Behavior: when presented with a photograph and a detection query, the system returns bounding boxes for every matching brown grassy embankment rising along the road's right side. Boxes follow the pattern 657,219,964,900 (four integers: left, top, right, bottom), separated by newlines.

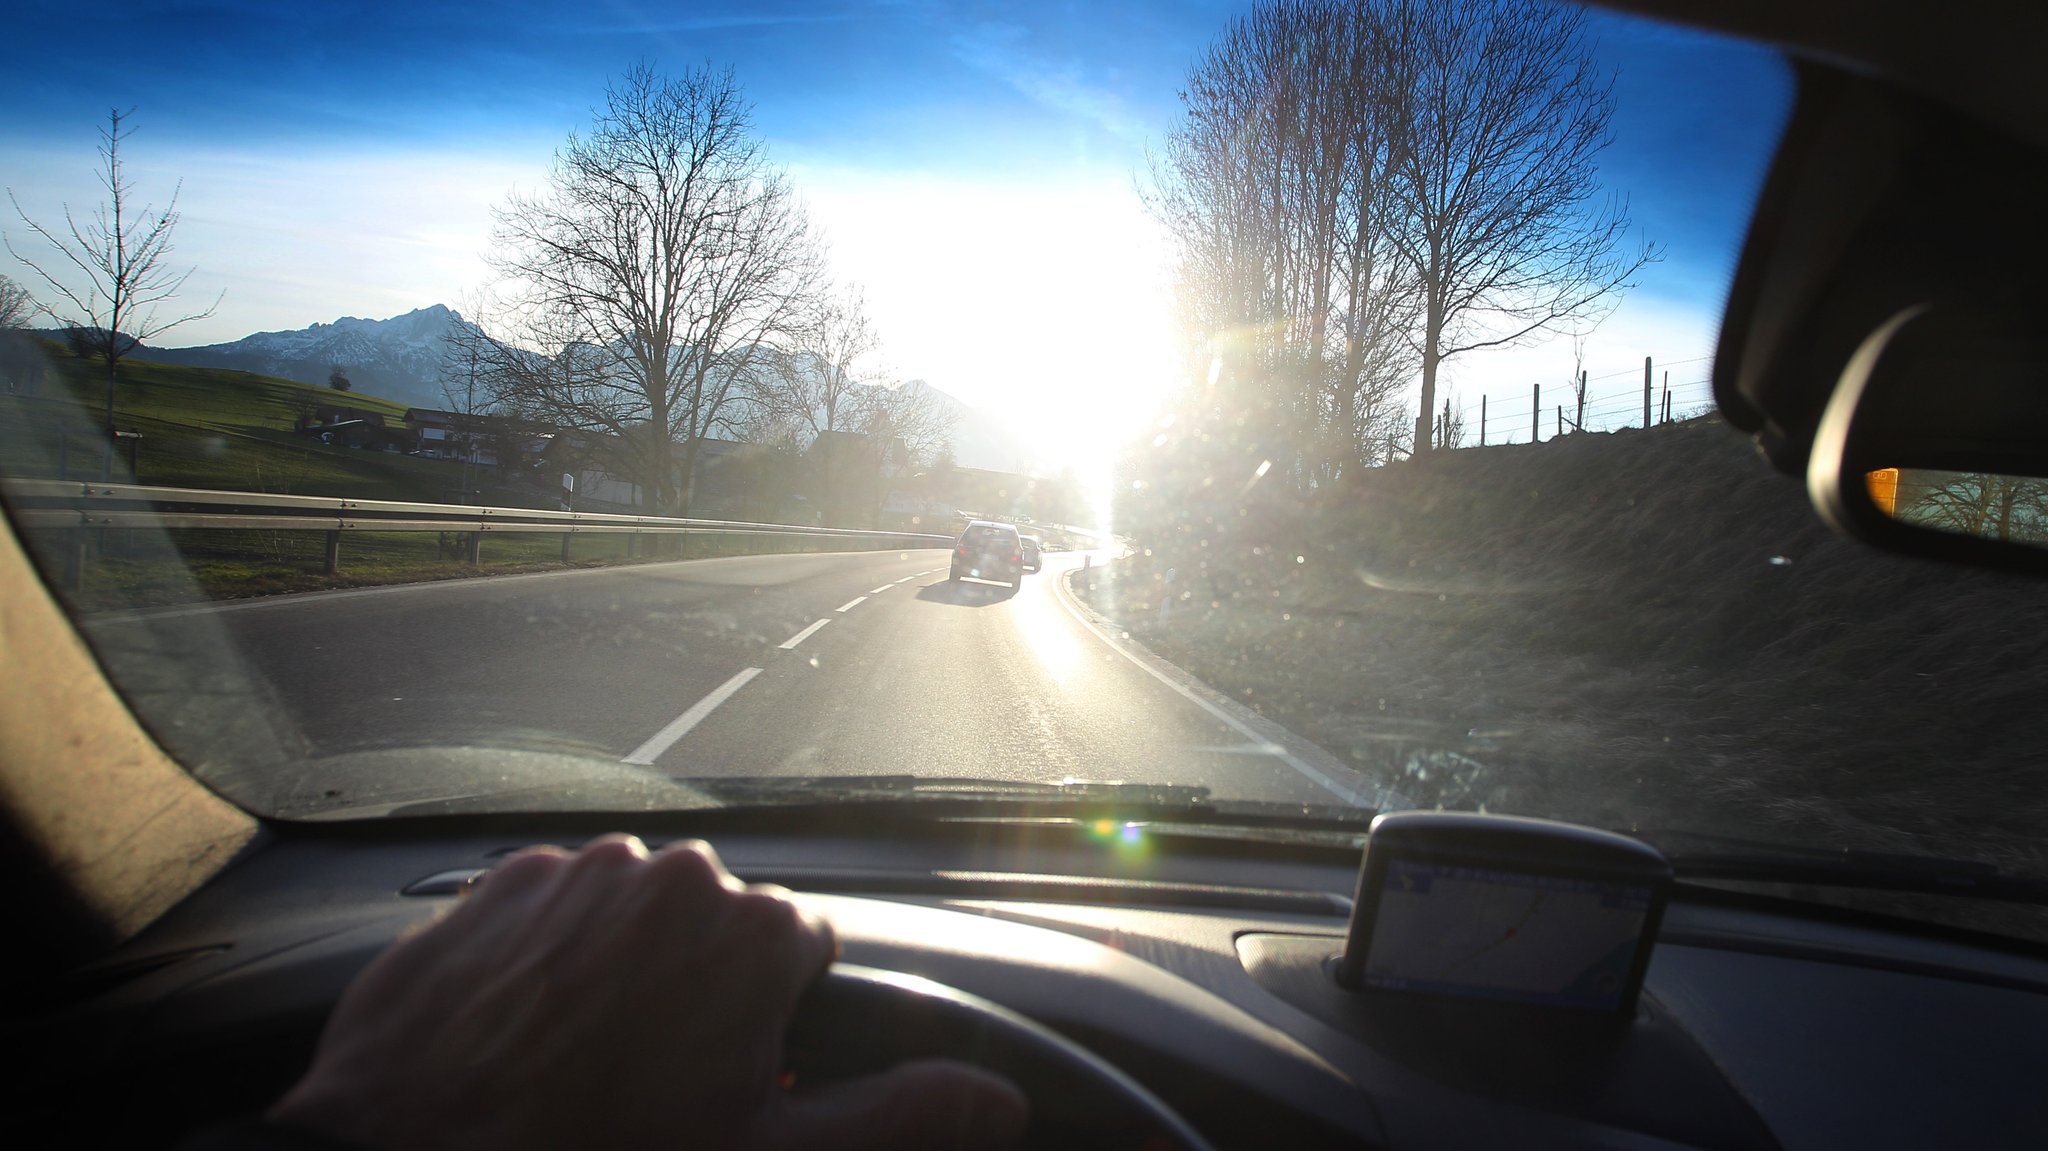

1094,422,2048,930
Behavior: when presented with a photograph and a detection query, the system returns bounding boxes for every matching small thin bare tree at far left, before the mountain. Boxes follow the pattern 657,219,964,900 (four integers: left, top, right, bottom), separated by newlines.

6,109,225,434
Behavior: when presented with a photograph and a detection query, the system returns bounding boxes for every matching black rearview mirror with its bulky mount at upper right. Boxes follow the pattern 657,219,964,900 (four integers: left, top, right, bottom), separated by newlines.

1714,59,2048,571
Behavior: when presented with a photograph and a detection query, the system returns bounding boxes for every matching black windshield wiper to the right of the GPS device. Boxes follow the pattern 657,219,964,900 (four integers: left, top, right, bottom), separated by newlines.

1624,832,2048,903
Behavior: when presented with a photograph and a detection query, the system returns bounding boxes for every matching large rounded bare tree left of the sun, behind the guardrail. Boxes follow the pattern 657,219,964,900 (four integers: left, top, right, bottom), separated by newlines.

475,66,821,512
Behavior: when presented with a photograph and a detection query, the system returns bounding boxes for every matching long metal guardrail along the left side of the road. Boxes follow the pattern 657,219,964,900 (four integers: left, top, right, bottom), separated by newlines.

0,479,952,590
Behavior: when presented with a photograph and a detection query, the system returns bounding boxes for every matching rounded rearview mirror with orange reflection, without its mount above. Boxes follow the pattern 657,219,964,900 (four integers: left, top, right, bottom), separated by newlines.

1806,303,2048,571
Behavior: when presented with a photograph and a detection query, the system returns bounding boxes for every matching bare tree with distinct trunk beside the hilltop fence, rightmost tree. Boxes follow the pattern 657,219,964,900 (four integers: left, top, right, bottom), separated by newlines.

1378,0,1657,453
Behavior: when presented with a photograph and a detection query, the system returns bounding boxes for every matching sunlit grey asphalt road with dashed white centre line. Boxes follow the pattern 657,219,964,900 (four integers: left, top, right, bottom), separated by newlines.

88,549,1376,807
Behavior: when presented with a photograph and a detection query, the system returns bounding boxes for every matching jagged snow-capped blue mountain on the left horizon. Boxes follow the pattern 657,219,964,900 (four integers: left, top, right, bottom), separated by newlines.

137,303,469,408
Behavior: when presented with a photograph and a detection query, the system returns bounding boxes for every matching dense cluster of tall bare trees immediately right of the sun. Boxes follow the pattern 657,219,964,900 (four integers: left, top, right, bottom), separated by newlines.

1153,0,1415,485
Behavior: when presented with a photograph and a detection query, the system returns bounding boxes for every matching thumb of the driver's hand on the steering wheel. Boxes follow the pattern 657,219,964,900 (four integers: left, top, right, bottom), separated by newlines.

760,1059,1030,1151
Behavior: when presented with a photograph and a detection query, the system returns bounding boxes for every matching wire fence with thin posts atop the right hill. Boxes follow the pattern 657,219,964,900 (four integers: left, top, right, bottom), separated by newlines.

1436,356,1714,449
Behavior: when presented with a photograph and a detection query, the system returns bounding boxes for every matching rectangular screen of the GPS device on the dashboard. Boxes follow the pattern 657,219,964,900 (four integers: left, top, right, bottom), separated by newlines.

1364,858,1651,1012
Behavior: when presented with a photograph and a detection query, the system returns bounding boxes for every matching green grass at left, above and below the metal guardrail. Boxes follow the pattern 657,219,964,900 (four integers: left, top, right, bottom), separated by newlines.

0,342,856,610
